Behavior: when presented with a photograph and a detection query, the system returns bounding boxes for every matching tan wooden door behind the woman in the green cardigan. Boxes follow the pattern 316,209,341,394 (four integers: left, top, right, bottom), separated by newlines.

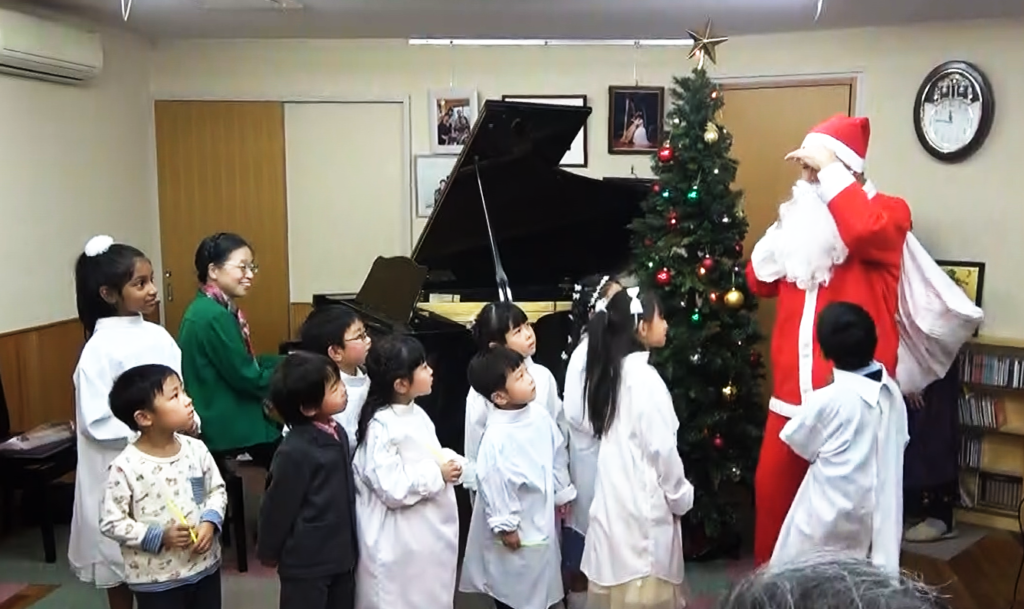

155,101,289,353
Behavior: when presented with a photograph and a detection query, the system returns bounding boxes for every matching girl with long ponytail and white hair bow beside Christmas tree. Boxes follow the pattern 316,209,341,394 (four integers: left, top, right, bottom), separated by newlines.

582,288,693,609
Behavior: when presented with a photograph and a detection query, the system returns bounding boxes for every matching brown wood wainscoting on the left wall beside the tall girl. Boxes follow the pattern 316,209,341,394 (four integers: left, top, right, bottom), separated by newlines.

0,308,160,431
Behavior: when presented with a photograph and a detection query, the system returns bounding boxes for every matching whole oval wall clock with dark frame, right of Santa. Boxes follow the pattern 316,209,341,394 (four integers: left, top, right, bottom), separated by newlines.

913,61,995,163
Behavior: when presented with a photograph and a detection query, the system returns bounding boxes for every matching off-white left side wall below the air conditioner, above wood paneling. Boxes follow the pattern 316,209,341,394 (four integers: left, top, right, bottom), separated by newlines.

0,26,159,333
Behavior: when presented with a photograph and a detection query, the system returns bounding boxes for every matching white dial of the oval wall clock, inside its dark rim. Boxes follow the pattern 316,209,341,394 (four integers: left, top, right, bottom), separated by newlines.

920,71,982,153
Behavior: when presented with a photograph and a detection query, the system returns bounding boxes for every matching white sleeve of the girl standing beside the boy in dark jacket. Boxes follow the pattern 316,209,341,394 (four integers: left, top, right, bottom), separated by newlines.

356,421,447,510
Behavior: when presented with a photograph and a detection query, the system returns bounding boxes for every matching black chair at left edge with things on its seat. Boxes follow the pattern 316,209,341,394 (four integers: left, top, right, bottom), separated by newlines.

0,364,78,563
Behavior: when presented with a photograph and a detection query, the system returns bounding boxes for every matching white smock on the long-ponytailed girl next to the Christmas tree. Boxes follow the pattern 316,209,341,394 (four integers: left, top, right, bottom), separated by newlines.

581,351,693,609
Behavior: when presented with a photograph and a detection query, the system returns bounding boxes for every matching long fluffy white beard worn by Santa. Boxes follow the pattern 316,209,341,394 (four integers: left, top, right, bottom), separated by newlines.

774,180,849,290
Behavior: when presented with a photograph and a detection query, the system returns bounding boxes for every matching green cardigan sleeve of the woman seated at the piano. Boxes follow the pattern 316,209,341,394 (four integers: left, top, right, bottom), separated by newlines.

197,311,275,399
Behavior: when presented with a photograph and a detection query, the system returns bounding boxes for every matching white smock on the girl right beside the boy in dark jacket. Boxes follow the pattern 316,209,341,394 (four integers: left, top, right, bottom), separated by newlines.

352,403,464,609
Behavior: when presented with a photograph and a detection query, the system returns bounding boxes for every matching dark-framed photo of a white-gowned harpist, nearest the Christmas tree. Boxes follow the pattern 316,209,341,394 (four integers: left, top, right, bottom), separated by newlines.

608,87,665,155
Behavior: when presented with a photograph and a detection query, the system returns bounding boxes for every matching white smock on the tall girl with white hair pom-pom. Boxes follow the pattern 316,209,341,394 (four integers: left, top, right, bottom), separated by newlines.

68,315,199,588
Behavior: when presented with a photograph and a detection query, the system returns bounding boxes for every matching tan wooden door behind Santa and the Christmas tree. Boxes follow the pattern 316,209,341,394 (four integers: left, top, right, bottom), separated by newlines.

722,79,856,403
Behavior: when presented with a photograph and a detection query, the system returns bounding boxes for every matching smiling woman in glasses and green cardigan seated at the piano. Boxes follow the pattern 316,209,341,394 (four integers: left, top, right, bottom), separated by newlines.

178,232,281,469
